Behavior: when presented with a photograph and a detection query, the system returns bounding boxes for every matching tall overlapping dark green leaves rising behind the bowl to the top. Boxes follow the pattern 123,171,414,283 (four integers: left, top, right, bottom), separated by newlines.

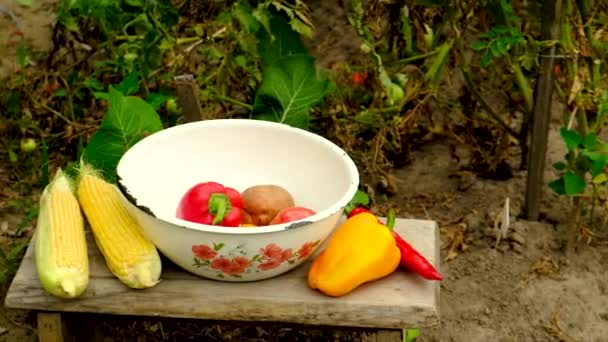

230,4,333,129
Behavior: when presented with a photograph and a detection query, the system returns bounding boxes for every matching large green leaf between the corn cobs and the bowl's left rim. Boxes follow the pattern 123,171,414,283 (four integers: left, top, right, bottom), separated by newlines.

83,87,163,181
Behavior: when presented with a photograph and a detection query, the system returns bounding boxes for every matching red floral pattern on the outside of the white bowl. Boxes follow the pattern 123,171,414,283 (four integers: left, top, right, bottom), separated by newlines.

192,240,321,278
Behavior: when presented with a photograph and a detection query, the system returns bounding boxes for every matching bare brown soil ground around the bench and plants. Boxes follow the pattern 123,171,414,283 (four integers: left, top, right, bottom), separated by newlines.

0,0,608,342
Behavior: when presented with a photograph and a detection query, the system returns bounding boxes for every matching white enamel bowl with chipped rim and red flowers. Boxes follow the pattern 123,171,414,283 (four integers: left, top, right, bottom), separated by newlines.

117,119,359,281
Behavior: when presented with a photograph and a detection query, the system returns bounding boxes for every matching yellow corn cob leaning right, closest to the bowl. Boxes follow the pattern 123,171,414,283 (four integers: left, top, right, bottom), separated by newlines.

78,164,161,289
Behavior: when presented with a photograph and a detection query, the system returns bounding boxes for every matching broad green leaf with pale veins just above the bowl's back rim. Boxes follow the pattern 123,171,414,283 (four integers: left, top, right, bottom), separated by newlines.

252,55,332,129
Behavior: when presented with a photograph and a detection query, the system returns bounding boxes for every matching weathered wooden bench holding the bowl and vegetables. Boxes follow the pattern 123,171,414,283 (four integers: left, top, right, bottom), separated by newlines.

5,219,440,342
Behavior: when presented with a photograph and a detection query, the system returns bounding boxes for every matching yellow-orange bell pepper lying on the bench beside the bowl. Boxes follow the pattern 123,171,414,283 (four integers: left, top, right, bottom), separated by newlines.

308,213,401,297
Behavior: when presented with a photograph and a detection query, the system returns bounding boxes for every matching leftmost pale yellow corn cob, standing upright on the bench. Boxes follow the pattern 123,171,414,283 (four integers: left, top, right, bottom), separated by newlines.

34,168,89,298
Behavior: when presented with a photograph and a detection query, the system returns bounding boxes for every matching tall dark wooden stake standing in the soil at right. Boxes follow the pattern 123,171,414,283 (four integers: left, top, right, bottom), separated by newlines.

525,0,562,221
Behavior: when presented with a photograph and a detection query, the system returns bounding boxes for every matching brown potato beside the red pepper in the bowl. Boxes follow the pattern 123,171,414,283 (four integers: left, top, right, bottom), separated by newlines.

241,184,295,226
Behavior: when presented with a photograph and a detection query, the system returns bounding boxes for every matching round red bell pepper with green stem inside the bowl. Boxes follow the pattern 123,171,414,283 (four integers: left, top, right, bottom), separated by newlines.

177,182,243,227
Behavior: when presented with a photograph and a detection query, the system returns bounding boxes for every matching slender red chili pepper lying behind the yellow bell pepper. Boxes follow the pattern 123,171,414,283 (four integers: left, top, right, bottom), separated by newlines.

347,207,443,280
